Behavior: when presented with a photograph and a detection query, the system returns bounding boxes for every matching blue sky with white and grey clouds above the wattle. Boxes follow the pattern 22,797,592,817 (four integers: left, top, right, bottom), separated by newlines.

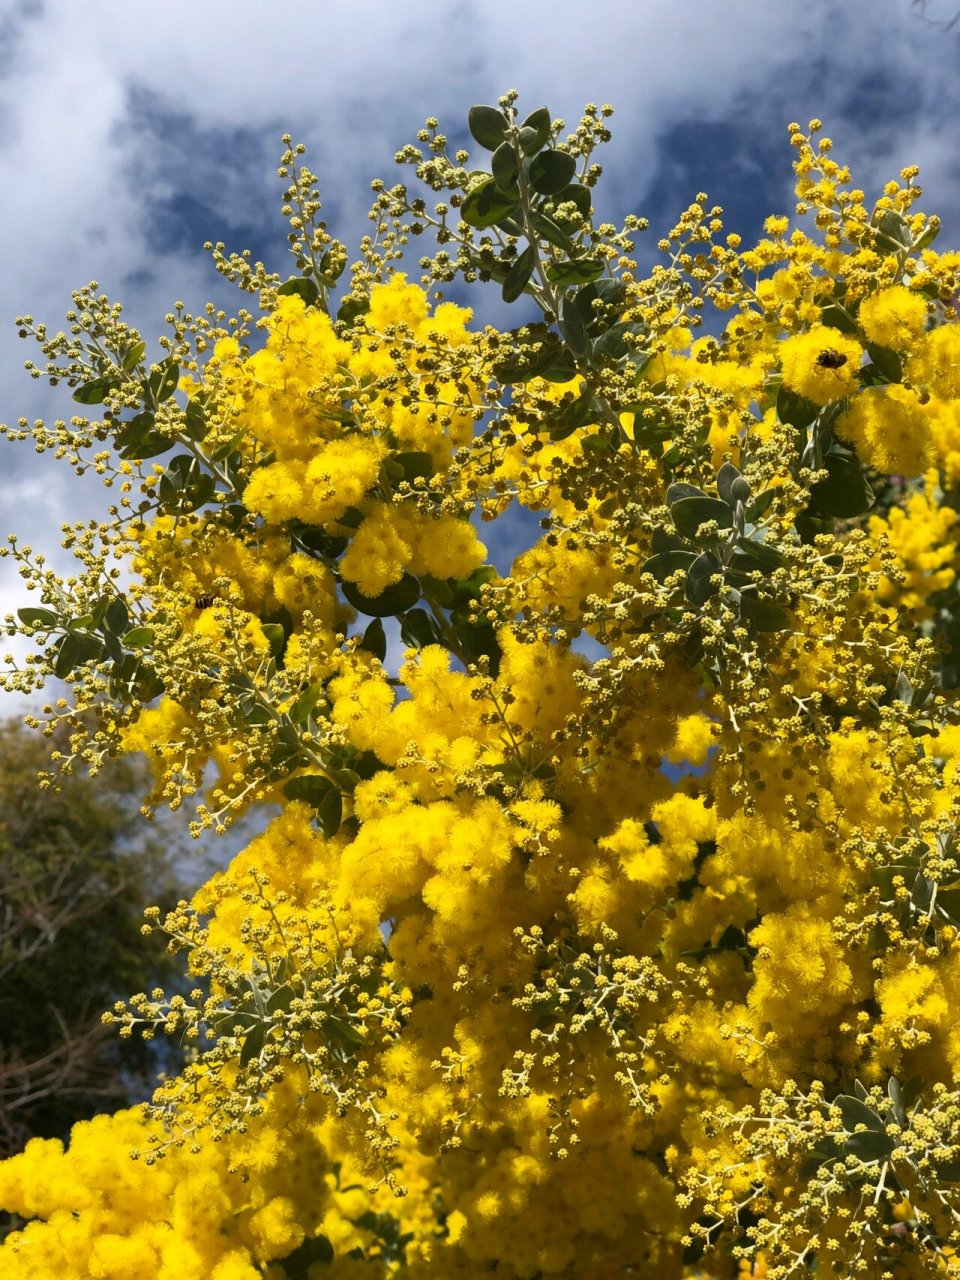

0,0,960,701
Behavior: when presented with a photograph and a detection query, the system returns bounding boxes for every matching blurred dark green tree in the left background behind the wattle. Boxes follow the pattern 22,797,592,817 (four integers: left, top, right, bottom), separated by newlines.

0,721,183,1156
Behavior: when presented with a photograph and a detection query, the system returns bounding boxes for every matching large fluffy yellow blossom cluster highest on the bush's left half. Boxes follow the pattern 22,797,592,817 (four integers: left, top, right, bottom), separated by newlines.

212,275,485,596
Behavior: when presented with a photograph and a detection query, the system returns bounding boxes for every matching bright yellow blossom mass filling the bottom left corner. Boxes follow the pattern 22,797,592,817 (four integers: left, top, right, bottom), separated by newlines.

0,1091,337,1280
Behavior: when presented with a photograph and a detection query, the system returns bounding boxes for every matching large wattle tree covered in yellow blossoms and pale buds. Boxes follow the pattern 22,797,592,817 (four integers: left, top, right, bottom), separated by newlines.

0,93,960,1280
